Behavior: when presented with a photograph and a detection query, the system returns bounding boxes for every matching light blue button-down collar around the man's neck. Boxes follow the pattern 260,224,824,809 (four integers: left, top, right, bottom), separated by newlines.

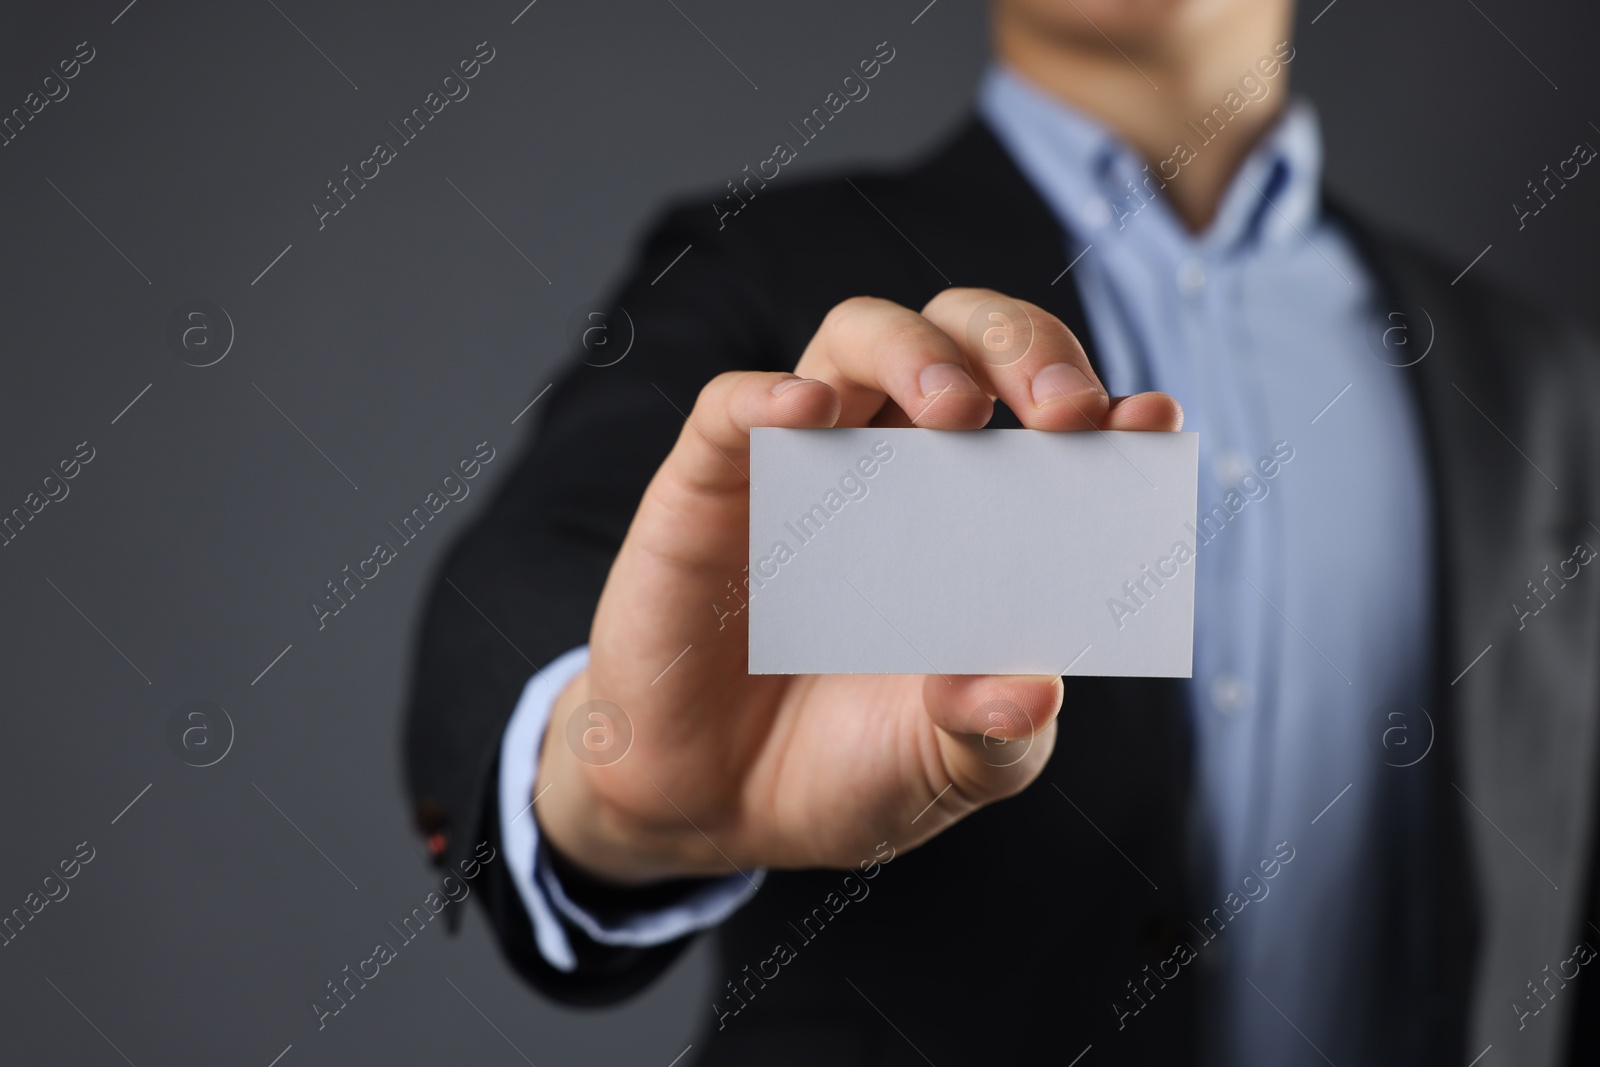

978,64,1322,254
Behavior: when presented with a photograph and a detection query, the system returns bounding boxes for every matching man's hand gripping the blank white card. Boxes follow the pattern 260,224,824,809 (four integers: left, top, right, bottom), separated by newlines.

536,290,1182,883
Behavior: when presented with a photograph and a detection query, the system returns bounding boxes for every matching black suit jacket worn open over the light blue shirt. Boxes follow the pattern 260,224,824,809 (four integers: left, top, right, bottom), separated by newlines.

406,122,1600,1067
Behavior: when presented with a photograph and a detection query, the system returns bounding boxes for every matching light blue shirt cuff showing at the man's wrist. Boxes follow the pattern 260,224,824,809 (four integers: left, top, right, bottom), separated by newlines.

499,646,766,971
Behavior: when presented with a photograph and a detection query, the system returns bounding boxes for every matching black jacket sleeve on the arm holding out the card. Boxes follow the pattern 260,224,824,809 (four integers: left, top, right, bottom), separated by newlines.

405,195,797,1003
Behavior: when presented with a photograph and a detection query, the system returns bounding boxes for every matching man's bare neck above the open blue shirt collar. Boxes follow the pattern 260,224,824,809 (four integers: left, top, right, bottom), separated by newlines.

994,13,1293,232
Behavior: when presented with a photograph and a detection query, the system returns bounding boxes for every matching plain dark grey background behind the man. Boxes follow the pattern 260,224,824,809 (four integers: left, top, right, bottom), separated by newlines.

0,0,1600,1067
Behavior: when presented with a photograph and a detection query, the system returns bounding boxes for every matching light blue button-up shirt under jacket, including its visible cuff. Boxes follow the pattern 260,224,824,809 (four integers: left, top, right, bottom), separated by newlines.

501,67,1434,1064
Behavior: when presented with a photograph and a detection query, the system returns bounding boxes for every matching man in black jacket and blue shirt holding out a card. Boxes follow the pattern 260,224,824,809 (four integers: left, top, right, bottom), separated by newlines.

408,0,1600,1065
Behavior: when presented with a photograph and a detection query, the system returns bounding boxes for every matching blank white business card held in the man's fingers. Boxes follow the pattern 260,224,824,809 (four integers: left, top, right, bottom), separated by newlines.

749,429,1198,678
